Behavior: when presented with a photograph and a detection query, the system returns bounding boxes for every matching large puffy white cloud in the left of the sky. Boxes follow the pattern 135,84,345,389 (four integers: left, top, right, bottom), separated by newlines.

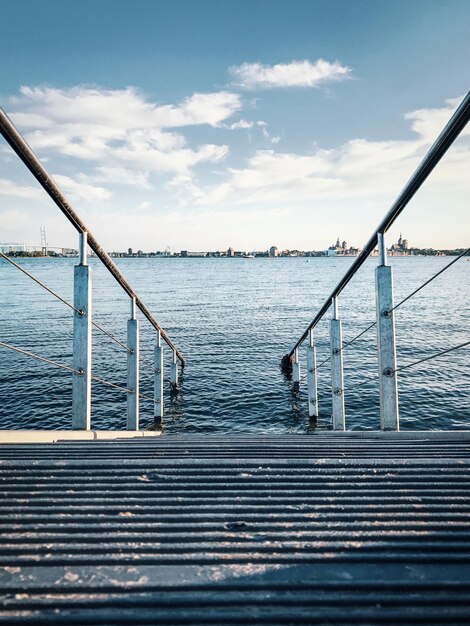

11,87,241,178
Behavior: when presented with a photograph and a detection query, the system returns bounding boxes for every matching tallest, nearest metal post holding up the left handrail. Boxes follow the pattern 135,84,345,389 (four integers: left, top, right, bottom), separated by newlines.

72,232,92,430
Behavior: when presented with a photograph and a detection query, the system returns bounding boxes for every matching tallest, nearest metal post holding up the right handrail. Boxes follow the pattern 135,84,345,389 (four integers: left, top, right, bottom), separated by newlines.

375,233,400,430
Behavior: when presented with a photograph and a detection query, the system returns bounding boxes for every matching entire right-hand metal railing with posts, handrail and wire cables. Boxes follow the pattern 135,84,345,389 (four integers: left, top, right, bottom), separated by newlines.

281,92,470,430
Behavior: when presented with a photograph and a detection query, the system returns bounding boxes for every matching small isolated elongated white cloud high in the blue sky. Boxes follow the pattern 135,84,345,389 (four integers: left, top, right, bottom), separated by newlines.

229,59,351,89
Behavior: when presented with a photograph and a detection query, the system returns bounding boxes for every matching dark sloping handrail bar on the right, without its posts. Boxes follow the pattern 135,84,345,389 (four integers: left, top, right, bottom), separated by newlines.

284,91,470,359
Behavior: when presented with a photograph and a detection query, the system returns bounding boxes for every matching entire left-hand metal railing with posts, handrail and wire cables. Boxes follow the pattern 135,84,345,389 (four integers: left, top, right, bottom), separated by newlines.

0,108,185,430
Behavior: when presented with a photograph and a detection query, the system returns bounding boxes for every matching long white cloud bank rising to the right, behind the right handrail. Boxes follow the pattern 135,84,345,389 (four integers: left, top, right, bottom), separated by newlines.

175,95,470,210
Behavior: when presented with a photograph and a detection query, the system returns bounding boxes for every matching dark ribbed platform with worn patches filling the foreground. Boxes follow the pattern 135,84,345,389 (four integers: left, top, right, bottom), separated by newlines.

0,433,470,625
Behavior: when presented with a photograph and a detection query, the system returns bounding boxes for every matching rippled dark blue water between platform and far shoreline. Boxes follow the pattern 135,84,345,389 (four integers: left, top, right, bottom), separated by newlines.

0,257,470,433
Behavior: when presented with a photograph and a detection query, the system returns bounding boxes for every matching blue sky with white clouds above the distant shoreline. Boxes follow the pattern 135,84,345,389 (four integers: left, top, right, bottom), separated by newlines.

0,0,470,250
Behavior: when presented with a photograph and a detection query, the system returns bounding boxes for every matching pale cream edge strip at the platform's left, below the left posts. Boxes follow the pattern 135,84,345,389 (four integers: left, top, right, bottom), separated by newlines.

0,430,162,445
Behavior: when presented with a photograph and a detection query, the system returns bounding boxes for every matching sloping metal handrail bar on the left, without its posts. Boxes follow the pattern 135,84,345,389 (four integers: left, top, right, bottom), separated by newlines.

0,107,186,368
